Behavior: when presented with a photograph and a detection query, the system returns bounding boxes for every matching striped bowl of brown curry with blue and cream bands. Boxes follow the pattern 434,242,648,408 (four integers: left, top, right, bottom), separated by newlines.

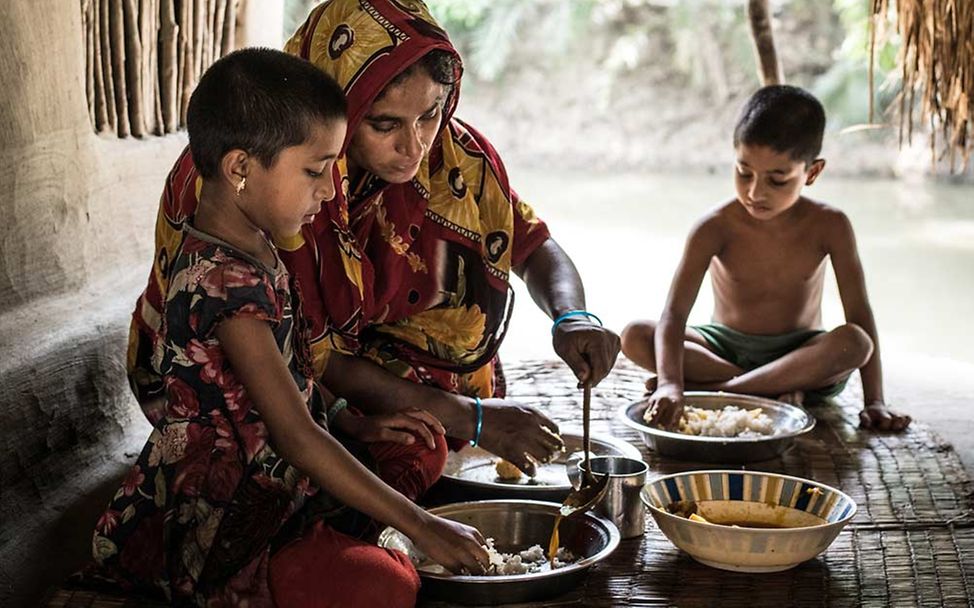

641,471,856,572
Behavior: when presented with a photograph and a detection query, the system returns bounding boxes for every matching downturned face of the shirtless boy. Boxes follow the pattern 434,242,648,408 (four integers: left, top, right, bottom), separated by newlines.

734,143,825,220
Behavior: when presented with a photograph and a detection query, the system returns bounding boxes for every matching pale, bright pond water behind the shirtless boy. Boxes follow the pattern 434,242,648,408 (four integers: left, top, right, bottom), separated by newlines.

501,168,974,365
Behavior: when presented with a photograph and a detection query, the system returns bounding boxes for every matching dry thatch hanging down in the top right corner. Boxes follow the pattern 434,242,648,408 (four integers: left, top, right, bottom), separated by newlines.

870,0,974,171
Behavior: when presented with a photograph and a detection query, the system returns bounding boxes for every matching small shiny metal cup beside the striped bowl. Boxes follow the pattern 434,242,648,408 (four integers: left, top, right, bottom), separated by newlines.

568,454,649,538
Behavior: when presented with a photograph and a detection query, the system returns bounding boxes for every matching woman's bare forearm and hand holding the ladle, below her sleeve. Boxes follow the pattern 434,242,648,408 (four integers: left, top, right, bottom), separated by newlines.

514,238,620,386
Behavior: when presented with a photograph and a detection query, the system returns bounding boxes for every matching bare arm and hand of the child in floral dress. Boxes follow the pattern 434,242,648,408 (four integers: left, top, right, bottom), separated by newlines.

215,317,486,572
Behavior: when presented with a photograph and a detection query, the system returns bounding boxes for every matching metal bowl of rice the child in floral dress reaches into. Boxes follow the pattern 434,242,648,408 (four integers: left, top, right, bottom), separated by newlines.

379,500,619,604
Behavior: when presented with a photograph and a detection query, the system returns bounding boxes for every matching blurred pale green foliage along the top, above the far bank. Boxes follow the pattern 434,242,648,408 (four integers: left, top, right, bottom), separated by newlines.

284,0,899,128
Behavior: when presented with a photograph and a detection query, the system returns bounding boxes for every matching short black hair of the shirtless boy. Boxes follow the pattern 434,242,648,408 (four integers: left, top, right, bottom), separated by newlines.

734,84,825,166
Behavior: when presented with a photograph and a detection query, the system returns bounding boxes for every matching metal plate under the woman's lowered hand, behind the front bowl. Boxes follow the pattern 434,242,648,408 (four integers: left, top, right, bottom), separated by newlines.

440,431,642,502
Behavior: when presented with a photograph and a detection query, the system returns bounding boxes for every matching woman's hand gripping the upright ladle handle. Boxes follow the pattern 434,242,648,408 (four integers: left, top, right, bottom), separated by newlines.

552,318,622,386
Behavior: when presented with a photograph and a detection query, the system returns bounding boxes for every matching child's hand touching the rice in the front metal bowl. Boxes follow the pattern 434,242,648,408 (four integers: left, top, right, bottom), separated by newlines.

412,513,489,574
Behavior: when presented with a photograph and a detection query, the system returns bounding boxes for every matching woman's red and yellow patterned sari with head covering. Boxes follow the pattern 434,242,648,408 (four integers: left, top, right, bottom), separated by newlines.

128,0,549,420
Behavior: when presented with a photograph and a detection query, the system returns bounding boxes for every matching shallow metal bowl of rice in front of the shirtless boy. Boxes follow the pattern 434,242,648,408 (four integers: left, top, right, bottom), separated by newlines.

619,391,815,464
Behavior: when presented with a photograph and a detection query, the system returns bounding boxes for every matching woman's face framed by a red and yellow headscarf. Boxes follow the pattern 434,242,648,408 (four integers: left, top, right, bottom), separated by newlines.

348,69,448,184
